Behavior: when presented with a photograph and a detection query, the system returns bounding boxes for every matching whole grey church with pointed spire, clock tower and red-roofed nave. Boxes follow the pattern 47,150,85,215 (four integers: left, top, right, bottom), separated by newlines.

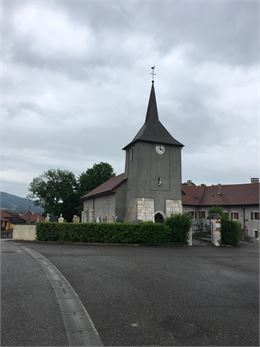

82,81,183,223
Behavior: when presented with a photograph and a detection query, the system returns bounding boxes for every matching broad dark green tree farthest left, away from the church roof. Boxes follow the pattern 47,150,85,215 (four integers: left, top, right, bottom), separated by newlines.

28,169,79,221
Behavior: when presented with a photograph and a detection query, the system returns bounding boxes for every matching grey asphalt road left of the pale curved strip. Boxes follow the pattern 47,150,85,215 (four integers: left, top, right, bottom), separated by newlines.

1,241,67,346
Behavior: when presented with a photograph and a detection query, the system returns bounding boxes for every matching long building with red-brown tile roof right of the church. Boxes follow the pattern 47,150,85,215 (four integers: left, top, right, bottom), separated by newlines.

182,179,260,238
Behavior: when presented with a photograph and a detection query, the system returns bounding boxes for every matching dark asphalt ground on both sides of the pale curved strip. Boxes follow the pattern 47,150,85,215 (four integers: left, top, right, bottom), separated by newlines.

2,242,259,346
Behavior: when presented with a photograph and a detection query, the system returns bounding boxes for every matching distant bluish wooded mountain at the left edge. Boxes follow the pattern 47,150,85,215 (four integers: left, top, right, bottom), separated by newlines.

0,192,43,214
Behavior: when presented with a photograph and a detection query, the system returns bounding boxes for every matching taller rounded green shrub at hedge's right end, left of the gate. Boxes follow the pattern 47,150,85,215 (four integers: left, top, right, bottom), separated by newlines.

165,214,191,245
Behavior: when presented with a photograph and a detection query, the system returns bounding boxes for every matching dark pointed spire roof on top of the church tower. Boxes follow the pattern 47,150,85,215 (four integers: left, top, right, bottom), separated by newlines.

123,83,183,149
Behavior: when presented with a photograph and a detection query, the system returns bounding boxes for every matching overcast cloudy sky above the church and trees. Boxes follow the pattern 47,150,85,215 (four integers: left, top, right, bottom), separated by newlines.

0,0,260,196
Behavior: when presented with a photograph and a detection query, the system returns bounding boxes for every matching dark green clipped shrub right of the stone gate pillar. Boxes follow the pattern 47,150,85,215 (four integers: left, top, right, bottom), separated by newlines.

221,218,242,246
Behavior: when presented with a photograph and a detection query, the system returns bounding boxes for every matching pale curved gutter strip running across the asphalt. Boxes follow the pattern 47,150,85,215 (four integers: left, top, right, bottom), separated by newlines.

21,246,103,346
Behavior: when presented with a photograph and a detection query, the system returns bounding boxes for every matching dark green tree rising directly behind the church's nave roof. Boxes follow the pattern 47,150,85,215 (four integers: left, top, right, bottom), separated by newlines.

78,162,115,196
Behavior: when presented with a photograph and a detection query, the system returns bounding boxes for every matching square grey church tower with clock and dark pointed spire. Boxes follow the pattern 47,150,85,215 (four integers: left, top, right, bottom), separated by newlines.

123,75,183,222
